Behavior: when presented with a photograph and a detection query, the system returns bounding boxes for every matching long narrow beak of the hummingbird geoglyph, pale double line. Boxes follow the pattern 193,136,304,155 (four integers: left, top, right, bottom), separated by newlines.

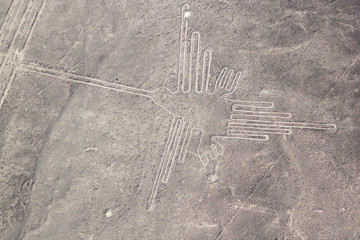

18,64,151,98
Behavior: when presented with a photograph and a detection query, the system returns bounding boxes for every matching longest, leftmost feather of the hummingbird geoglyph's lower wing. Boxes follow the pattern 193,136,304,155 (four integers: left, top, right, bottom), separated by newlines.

148,117,177,210
